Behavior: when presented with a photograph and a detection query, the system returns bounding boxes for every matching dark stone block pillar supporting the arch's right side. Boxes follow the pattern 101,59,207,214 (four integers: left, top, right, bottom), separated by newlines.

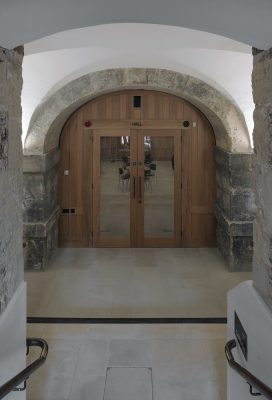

215,148,255,271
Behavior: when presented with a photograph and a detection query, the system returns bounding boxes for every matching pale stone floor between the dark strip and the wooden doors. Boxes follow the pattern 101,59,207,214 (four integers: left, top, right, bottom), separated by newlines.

26,248,251,317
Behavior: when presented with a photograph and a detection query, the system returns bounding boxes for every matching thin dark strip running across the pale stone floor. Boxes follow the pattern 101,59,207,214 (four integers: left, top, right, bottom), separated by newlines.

27,317,227,324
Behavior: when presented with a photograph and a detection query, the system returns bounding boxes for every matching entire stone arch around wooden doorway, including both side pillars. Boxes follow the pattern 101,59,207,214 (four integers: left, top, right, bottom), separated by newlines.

24,68,255,271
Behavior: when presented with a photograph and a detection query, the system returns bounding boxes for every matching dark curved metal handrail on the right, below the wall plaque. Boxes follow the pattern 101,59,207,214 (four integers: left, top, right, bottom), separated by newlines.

225,339,272,400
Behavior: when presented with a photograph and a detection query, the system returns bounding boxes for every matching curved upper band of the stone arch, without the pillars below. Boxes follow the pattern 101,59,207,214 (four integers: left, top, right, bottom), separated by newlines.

24,68,251,155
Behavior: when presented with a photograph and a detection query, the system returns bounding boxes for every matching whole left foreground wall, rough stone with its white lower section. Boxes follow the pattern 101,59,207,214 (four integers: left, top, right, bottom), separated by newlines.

0,47,26,400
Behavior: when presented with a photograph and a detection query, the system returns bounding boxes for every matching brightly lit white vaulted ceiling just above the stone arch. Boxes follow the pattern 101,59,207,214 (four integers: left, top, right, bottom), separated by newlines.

22,24,254,145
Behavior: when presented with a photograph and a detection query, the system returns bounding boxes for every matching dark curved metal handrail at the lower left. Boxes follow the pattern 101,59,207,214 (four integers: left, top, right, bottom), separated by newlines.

0,338,48,399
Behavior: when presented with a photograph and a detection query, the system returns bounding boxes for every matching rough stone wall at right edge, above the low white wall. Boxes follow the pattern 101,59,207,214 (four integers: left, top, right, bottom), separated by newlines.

252,49,272,308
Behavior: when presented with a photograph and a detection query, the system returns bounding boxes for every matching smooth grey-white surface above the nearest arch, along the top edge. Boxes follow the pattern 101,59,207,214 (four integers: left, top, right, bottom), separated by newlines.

0,0,272,48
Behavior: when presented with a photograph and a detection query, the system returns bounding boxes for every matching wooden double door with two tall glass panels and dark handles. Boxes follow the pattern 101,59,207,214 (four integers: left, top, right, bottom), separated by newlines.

93,129,181,247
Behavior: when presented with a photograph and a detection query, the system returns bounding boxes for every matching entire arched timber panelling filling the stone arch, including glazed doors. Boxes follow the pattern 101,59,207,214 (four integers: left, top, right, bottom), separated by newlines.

59,90,215,247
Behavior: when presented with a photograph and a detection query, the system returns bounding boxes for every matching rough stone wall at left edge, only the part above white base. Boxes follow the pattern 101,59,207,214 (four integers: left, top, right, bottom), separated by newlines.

0,47,23,313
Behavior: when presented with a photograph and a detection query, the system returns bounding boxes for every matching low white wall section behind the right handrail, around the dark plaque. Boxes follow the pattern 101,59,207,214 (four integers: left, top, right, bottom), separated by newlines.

227,281,272,400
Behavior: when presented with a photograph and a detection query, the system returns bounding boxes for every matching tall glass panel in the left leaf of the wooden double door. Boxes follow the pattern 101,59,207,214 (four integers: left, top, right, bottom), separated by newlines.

94,132,130,247
